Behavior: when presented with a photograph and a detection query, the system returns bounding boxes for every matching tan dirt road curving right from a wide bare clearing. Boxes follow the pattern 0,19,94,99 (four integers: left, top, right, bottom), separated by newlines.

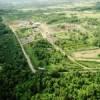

40,24,99,72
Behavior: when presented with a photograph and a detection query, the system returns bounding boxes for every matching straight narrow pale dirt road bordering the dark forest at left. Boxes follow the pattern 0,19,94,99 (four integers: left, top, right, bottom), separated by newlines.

9,26,36,73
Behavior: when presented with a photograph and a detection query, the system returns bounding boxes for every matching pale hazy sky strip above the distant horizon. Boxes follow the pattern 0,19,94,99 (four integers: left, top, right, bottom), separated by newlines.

0,0,70,8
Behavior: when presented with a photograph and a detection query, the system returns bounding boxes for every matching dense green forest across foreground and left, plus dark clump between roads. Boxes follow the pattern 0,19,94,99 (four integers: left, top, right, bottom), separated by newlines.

0,15,100,100
